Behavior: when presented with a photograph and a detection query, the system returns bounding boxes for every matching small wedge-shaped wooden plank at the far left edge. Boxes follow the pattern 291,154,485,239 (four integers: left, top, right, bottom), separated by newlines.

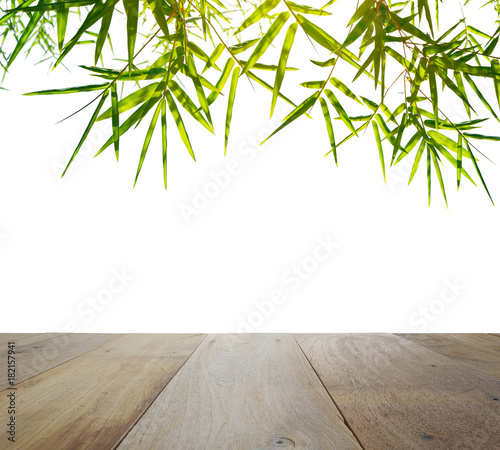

0,333,122,391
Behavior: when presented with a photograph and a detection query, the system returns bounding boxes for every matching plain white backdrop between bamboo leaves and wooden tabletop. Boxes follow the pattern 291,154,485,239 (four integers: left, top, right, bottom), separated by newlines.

0,3,500,332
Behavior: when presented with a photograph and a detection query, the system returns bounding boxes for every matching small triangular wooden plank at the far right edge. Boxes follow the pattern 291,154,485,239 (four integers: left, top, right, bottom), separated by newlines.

397,333,500,379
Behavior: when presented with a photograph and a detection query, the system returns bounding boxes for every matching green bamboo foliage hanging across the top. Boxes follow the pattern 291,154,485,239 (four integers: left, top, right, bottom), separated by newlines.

0,0,500,203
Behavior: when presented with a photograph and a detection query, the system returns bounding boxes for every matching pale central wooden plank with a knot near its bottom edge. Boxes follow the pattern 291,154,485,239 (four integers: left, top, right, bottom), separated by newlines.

118,334,360,450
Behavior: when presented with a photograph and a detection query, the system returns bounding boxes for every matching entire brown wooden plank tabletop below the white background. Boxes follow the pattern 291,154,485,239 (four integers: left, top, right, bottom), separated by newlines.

0,333,500,450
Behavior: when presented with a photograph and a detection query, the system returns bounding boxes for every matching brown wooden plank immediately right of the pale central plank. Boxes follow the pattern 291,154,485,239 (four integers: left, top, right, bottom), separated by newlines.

296,334,500,450
